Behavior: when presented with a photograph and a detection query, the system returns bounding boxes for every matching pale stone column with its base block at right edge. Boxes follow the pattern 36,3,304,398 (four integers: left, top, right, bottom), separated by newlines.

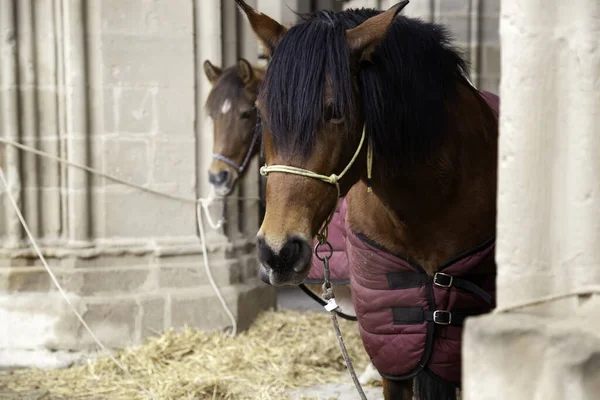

463,0,600,400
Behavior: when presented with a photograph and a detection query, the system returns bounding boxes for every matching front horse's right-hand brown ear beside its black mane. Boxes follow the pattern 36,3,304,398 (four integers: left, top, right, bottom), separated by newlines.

346,0,409,60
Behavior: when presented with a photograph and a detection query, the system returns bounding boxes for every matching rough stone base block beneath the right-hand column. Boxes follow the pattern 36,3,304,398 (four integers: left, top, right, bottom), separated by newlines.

463,298,600,400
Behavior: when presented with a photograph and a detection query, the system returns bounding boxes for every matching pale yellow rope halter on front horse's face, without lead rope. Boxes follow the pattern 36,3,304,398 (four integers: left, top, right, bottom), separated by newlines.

260,128,373,238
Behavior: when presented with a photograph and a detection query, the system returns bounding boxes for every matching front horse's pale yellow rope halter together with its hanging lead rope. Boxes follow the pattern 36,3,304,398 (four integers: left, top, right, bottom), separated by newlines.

260,128,373,400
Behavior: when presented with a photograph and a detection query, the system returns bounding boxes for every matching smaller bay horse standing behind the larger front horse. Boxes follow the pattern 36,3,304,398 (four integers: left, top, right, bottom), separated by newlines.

203,58,380,383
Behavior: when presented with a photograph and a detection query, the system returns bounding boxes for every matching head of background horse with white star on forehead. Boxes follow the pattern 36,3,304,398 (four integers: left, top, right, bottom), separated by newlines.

204,59,262,196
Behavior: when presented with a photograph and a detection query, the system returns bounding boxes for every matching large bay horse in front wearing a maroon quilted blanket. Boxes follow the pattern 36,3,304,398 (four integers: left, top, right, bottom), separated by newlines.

236,0,499,400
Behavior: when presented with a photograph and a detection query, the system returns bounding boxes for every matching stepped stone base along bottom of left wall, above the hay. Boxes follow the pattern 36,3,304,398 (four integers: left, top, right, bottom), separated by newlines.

0,249,277,368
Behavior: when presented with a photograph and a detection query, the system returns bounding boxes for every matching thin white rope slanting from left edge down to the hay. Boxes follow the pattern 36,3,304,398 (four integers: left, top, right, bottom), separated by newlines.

0,167,158,400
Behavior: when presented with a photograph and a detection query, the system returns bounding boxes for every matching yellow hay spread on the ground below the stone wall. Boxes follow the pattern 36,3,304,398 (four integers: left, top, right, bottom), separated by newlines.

0,311,368,400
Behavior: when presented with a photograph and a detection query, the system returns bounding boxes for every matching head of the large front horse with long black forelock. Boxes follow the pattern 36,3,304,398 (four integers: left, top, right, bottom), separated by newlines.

236,0,408,285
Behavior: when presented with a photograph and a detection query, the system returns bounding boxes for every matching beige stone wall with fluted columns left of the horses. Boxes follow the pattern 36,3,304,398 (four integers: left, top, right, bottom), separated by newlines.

0,0,275,366
